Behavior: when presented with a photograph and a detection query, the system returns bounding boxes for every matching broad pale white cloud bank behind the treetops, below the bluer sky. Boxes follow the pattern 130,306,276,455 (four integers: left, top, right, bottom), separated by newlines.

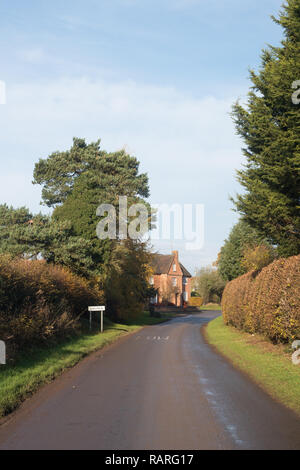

0,77,244,264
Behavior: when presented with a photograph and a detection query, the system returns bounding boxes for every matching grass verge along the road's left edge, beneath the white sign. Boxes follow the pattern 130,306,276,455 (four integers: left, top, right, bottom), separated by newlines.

0,312,170,417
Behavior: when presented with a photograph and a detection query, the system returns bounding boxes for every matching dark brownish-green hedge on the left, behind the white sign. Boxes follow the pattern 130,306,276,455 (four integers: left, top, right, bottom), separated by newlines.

0,255,103,353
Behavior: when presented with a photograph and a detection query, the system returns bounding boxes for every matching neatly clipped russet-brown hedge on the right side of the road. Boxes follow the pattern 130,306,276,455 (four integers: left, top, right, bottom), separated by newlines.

222,255,300,342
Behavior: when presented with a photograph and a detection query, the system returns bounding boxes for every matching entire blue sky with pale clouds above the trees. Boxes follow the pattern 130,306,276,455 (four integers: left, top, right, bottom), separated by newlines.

0,0,282,271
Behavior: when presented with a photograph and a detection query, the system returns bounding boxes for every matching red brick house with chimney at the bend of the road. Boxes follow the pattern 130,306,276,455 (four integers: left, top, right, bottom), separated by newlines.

150,251,192,307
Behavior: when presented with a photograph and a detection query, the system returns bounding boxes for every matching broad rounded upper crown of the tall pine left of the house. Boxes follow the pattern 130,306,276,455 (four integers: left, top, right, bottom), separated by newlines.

33,138,149,207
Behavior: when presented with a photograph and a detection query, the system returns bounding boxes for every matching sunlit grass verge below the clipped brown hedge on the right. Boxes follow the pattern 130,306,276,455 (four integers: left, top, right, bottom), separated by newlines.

205,317,300,415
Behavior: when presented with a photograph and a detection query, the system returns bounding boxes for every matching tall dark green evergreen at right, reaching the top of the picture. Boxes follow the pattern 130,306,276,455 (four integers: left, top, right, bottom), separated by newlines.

233,0,300,256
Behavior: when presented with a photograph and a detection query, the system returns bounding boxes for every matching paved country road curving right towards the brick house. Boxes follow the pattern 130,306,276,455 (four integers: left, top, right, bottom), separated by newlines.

0,312,300,450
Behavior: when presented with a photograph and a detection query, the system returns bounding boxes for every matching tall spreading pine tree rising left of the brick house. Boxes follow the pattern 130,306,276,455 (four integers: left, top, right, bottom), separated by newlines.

34,138,150,275
